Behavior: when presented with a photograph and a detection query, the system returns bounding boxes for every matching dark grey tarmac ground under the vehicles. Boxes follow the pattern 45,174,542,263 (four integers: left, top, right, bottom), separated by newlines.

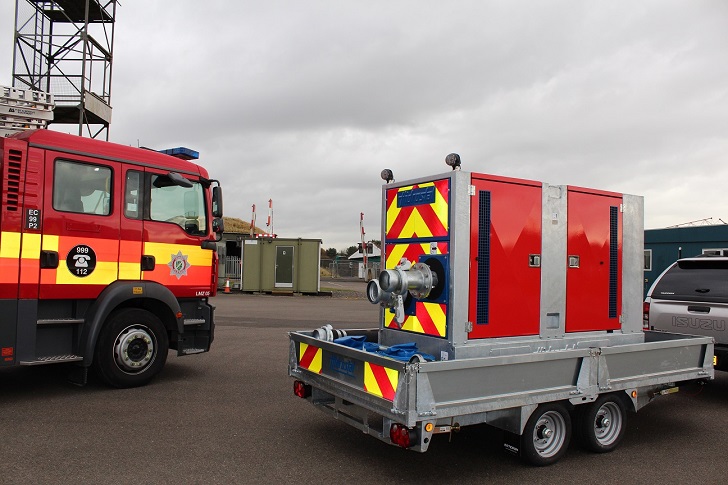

0,281,728,484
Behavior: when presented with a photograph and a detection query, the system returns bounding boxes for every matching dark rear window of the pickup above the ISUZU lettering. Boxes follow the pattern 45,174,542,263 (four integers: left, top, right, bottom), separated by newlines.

652,258,728,303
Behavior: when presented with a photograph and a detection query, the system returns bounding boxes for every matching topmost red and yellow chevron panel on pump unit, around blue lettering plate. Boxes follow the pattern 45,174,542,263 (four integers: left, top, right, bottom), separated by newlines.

385,179,450,239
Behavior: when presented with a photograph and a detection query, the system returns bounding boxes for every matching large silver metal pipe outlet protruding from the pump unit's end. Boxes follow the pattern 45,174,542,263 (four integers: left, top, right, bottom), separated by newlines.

367,258,441,326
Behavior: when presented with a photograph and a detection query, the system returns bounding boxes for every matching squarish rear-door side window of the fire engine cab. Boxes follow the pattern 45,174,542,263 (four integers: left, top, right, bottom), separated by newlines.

53,160,111,216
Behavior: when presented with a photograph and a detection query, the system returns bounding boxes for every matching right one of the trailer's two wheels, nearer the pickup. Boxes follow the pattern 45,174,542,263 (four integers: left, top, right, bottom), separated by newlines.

577,394,627,453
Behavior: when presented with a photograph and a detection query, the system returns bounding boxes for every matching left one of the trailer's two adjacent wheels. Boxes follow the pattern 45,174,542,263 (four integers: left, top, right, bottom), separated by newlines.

521,403,571,466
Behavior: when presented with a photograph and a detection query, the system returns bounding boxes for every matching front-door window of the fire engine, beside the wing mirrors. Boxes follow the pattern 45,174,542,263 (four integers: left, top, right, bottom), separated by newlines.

149,175,207,236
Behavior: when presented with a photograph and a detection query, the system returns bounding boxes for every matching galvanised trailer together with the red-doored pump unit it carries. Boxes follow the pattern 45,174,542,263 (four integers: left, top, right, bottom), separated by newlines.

289,154,713,465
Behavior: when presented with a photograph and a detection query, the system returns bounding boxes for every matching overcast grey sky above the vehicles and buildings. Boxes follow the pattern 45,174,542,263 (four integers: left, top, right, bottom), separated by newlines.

0,0,728,249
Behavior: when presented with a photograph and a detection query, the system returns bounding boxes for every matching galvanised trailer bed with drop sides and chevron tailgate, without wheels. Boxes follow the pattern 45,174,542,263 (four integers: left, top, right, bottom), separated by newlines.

289,330,713,451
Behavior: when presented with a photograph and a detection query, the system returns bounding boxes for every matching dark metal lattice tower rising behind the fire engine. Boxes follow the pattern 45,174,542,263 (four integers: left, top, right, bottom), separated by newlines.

13,0,118,140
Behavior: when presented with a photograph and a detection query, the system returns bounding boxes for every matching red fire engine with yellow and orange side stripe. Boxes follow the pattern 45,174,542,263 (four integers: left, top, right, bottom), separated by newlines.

0,130,223,387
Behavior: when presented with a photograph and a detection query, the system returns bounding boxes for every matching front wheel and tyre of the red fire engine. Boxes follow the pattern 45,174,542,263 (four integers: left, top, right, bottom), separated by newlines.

93,308,169,388
